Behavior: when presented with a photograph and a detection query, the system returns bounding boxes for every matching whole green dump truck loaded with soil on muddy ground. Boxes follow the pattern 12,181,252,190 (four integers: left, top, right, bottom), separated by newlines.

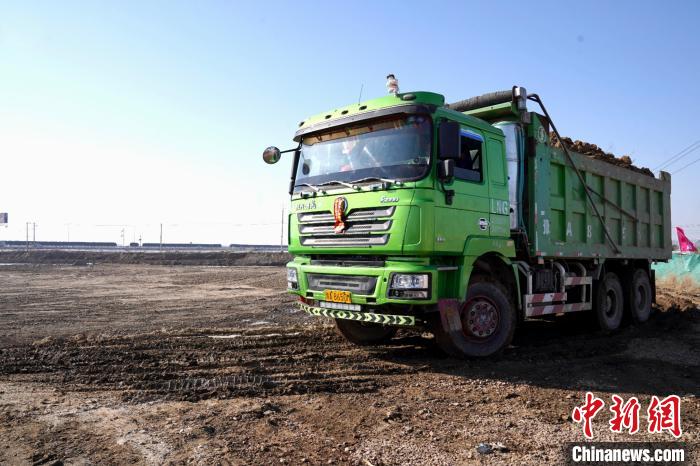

263,86,671,357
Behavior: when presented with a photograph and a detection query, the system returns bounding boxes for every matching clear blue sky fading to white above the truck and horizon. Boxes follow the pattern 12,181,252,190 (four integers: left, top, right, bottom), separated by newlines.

0,1,700,243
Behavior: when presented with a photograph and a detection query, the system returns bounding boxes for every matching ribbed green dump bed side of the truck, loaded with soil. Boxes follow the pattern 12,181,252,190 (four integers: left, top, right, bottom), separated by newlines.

523,115,671,260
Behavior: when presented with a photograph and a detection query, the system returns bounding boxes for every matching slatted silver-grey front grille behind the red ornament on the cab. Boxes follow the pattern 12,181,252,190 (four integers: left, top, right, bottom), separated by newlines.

297,206,396,247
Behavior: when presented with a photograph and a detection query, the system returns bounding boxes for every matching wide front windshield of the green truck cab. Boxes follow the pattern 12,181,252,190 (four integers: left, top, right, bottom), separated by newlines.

295,115,431,189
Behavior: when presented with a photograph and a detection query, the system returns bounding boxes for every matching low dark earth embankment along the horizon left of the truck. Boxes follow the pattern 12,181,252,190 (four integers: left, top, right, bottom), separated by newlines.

0,249,291,266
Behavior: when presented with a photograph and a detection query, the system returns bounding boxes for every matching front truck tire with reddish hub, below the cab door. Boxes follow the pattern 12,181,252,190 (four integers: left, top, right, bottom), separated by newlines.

434,281,517,359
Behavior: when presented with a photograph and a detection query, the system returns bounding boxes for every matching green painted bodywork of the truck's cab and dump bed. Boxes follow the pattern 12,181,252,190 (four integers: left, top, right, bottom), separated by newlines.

280,88,671,325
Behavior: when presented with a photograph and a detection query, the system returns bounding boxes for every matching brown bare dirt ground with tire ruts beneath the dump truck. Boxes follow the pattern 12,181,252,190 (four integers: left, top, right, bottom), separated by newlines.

0,264,700,465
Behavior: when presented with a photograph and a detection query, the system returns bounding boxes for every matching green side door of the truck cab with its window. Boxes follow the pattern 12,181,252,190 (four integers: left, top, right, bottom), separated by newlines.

435,126,490,252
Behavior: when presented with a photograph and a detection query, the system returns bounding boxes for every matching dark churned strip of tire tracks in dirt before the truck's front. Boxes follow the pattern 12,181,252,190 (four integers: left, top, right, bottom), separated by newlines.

0,329,422,402
